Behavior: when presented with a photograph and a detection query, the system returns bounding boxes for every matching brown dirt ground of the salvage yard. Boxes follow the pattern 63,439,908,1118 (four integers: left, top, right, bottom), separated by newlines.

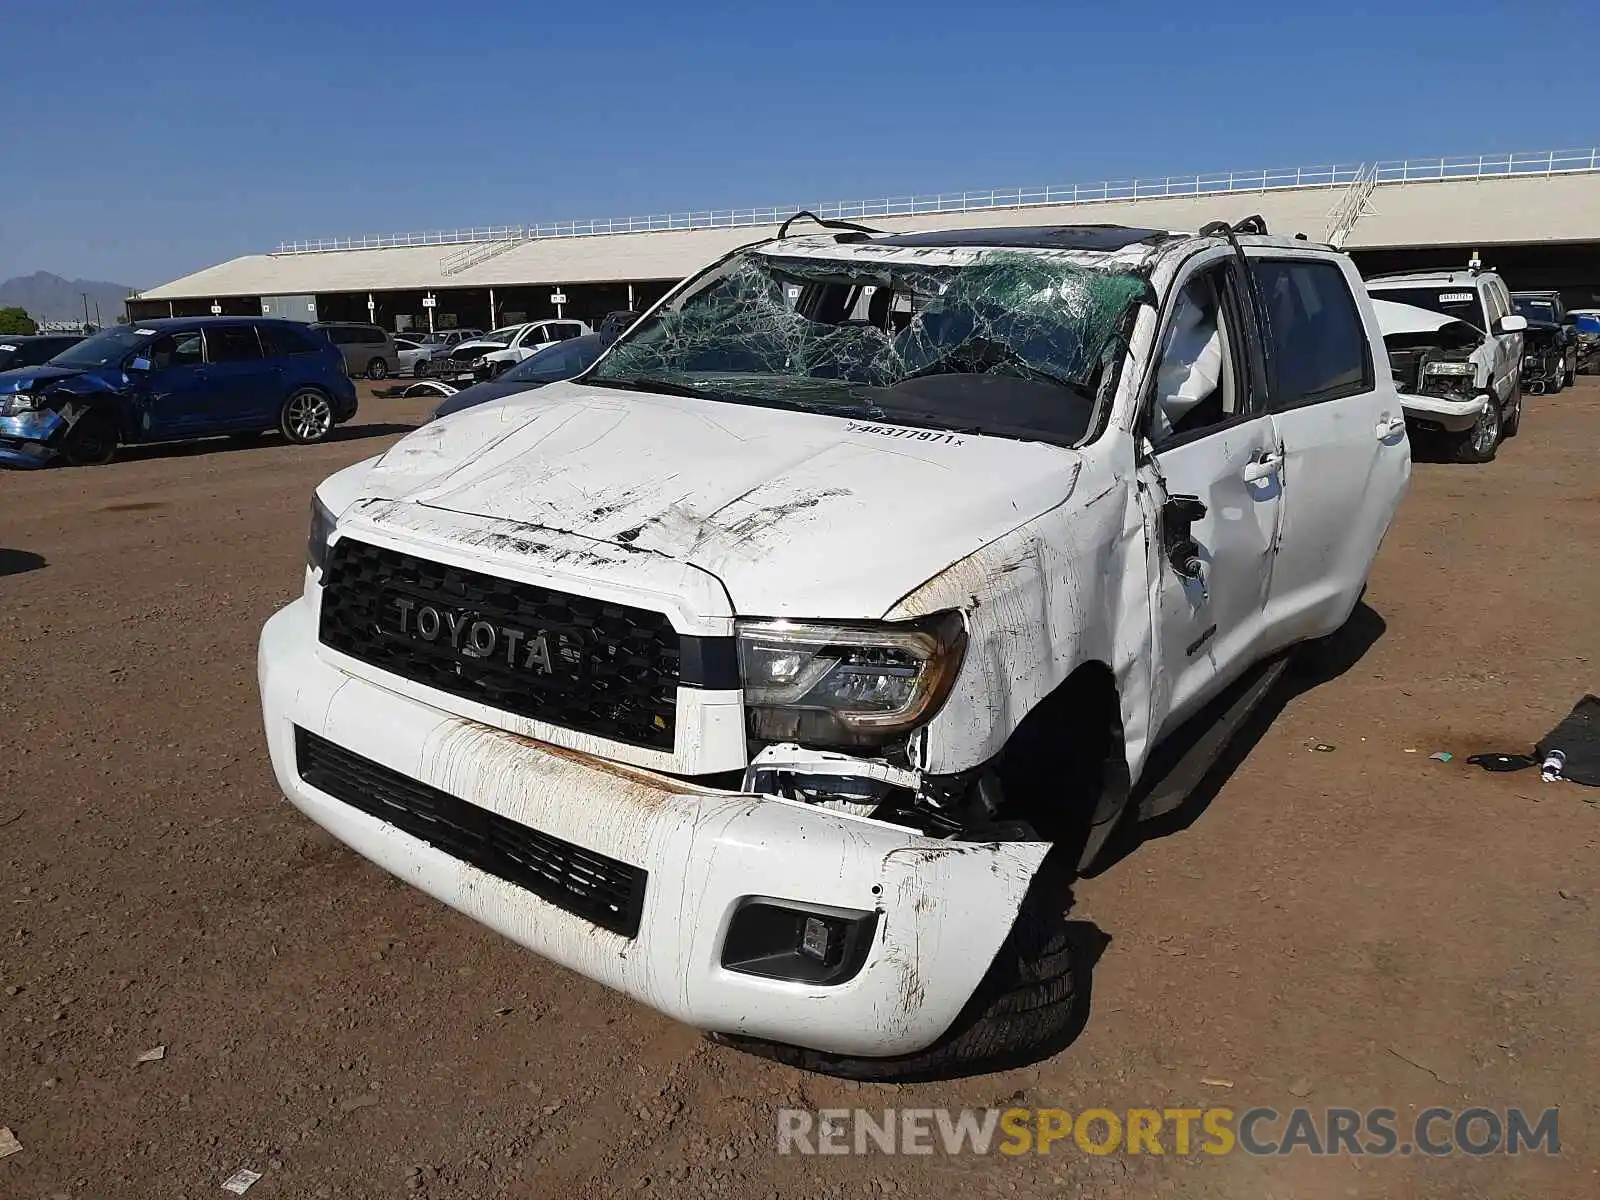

0,379,1600,1200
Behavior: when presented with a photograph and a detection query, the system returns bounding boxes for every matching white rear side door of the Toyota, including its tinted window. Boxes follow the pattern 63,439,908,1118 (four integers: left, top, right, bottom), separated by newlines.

1251,250,1410,648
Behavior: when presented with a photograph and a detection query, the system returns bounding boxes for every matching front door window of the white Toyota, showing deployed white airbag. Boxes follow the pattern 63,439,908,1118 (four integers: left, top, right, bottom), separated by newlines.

1146,267,1245,448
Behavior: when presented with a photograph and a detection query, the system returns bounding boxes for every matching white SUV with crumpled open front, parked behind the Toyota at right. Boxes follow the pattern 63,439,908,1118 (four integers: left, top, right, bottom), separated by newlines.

1366,259,1528,462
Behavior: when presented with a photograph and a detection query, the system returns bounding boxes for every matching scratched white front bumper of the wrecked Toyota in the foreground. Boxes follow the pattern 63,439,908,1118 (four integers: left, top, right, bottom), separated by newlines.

258,600,1048,1056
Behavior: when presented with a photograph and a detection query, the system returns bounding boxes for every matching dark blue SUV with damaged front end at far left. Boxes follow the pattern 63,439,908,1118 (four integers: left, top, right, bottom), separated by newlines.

0,317,355,467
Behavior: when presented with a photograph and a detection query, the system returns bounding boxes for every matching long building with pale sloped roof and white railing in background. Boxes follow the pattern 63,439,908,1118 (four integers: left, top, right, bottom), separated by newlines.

130,149,1600,328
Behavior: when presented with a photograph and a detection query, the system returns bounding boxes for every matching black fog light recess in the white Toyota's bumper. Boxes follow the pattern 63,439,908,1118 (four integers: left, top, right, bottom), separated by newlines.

722,896,878,987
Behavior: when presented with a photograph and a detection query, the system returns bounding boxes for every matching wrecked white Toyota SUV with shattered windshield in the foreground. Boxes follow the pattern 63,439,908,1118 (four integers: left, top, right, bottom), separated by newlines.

258,218,1410,1078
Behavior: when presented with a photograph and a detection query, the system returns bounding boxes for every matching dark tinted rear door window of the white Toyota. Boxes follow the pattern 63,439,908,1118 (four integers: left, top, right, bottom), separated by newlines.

1254,261,1373,410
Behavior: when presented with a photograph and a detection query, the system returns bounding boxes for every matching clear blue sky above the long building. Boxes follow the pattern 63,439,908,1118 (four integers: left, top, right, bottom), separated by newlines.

0,0,1600,286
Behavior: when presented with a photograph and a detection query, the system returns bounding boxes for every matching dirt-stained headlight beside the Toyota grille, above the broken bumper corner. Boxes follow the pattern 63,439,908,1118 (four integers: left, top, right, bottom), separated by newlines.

739,613,966,746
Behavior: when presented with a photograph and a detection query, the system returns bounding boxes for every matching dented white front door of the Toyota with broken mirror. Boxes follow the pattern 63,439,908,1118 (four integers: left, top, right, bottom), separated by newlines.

1139,254,1283,738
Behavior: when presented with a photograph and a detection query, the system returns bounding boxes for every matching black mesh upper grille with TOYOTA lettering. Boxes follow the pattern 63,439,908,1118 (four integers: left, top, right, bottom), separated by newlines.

318,538,682,750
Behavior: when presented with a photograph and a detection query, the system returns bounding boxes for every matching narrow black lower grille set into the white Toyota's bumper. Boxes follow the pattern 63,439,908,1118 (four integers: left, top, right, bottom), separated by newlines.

294,726,648,938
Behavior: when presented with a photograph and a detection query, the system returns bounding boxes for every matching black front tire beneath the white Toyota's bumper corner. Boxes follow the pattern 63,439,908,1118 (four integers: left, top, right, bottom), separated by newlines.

715,861,1083,1083
